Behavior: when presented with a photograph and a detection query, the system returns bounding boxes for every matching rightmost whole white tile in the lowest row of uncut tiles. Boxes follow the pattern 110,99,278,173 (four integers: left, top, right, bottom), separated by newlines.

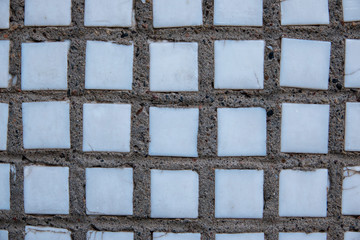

279,169,329,217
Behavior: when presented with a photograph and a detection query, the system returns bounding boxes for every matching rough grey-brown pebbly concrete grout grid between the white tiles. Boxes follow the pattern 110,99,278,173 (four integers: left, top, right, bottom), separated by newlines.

0,0,360,240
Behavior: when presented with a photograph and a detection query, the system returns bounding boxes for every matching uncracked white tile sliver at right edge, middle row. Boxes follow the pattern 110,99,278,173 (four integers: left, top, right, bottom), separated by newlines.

345,102,360,151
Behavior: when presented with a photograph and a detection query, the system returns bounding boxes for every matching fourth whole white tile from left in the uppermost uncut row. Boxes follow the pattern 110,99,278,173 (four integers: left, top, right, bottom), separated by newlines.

215,40,265,89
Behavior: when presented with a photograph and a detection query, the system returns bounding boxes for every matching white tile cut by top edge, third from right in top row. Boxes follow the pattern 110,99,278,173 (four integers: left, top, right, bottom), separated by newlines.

214,0,263,26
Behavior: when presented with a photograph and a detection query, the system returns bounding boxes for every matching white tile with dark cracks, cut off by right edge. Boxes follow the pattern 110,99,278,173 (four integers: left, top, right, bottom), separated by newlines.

341,166,360,215
